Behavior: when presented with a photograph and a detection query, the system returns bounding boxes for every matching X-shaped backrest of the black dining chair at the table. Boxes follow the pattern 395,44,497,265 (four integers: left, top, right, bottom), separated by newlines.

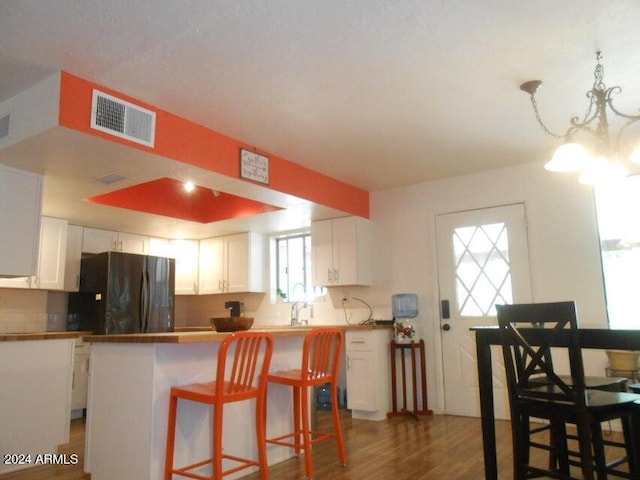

496,302,585,408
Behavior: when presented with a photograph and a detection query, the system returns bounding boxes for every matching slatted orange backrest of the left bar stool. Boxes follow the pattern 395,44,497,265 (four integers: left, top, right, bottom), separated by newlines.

216,330,273,399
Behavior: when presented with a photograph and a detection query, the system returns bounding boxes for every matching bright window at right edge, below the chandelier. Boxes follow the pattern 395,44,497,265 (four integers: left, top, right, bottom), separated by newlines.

596,175,640,329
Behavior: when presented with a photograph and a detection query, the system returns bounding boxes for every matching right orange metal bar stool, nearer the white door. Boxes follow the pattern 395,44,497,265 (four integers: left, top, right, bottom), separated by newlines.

267,327,347,479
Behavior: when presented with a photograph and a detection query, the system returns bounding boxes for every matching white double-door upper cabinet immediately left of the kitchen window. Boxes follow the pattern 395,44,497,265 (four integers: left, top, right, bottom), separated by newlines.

198,232,265,294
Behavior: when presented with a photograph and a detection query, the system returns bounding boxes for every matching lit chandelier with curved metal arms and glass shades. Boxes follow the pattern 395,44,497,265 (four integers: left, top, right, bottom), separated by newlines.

520,51,640,185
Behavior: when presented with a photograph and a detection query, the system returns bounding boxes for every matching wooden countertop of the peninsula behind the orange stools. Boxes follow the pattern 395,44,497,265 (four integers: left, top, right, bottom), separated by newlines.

84,325,392,343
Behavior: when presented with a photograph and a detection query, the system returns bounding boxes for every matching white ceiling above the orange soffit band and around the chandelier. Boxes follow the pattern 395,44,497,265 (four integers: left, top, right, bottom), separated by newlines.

0,0,640,237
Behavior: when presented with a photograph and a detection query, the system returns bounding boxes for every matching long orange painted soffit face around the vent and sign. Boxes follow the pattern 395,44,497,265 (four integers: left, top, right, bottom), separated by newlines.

59,72,369,218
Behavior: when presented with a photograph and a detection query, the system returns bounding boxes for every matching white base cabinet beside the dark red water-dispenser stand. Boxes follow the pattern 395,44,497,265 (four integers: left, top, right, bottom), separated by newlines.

345,328,391,420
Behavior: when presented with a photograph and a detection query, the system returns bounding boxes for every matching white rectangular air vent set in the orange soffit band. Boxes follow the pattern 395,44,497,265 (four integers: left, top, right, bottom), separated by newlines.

91,90,156,147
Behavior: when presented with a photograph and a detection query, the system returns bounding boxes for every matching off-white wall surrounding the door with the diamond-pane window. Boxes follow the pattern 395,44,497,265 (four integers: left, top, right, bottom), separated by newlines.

371,160,607,408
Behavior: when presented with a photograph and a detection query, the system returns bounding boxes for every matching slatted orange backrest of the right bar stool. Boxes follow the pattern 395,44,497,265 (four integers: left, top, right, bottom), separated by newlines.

302,327,344,381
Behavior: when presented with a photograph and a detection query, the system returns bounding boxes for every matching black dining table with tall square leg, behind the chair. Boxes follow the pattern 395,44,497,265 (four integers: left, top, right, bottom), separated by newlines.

471,326,640,480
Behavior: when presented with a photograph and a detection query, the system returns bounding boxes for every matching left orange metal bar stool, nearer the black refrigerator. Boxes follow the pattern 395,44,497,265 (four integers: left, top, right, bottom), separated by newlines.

164,331,273,480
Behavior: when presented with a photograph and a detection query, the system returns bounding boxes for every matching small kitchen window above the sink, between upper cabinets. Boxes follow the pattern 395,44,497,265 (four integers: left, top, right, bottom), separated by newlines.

276,233,313,302
